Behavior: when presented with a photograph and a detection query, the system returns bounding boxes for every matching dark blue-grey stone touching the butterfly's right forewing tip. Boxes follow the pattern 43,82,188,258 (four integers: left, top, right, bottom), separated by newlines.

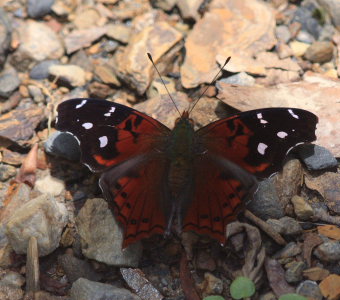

298,145,338,171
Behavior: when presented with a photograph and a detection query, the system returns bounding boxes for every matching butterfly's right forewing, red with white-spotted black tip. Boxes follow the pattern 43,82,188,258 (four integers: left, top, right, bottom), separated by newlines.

197,108,318,177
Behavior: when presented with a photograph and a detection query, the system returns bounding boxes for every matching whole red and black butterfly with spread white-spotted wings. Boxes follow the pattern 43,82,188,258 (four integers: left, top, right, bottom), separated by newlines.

56,98,318,247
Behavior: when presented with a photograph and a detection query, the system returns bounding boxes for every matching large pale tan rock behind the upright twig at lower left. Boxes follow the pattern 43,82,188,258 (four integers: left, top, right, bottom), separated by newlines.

6,195,68,256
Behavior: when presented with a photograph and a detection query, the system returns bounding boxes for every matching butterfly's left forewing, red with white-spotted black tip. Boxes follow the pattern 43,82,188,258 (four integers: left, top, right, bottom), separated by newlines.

56,98,170,172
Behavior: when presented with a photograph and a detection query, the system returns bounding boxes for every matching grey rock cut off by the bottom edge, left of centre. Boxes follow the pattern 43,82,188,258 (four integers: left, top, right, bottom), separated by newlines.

71,278,141,300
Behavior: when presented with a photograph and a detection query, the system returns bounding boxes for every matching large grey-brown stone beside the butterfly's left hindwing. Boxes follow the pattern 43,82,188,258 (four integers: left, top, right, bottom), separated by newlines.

76,198,142,267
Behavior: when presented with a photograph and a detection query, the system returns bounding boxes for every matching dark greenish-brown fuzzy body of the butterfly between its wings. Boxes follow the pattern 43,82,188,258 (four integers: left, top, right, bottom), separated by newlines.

167,114,195,198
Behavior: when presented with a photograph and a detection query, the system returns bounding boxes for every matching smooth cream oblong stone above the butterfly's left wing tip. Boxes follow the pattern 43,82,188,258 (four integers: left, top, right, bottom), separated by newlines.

48,65,86,87
